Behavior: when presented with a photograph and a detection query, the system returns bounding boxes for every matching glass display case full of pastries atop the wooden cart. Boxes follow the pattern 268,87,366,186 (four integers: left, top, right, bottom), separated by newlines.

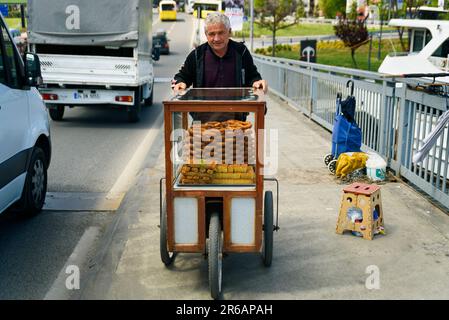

168,88,261,188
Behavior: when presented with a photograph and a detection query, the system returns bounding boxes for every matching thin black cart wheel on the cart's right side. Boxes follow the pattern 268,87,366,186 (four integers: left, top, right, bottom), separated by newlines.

262,191,273,267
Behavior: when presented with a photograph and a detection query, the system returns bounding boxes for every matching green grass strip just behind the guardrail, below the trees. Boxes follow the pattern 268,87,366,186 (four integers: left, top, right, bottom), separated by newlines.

262,39,402,71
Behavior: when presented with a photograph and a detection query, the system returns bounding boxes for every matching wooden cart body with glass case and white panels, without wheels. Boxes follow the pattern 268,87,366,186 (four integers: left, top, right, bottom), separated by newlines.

164,88,265,252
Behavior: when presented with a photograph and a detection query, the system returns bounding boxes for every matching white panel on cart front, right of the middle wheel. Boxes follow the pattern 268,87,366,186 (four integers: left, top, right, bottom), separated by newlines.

231,198,256,245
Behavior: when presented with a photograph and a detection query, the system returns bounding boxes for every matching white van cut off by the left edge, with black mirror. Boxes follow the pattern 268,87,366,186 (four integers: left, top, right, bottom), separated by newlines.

0,14,51,214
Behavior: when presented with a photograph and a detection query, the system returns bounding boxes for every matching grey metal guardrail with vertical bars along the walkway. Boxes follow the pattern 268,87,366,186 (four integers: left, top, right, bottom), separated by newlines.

253,54,449,209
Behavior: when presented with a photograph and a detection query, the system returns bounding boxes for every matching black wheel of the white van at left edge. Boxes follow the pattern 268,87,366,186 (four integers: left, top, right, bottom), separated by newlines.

18,147,48,215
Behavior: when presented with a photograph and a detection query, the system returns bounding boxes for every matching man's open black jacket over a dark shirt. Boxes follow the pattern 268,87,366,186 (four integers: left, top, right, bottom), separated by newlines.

174,40,262,88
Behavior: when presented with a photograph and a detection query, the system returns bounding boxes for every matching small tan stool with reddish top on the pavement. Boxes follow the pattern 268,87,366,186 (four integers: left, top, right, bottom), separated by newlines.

336,182,384,240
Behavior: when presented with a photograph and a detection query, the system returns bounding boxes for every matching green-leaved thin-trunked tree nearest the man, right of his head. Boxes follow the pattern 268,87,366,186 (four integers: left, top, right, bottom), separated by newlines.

254,0,304,57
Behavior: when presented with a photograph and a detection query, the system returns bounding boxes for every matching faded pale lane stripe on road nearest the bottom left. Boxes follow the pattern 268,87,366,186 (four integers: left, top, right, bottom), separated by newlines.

44,227,100,300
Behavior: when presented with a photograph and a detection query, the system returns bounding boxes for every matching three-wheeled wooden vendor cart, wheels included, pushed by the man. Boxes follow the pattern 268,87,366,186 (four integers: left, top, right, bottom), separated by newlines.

160,88,279,299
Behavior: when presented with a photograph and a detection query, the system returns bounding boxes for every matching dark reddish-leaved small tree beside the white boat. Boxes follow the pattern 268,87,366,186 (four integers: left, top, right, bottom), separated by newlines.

334,17,369,68
